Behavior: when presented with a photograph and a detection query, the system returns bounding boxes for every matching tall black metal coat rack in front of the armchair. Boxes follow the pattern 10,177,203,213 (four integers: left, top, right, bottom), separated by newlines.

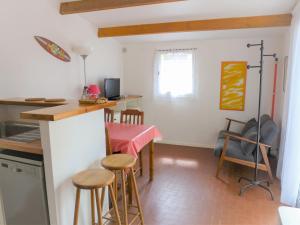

239,40,277,200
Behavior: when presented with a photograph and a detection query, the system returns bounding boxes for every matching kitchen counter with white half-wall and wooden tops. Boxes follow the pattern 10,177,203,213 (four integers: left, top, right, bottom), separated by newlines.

0,98,110,225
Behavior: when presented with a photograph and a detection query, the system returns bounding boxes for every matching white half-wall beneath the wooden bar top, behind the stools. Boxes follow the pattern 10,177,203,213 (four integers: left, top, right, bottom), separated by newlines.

40,110,107,225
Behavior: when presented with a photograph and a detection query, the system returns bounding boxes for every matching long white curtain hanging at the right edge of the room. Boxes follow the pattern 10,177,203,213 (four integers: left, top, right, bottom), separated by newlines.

281,4,300,206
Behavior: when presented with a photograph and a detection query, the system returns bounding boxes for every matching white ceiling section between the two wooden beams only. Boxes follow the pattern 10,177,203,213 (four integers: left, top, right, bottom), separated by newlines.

65,0,297,27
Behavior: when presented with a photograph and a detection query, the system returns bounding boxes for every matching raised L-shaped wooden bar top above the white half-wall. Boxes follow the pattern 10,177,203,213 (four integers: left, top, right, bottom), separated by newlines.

0,98,116,121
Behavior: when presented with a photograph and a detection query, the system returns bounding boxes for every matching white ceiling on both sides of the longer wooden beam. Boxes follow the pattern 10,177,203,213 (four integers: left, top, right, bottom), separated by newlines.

63,0,298,43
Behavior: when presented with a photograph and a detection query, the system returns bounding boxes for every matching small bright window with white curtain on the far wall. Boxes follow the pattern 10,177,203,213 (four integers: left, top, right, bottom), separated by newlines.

154,50,195,97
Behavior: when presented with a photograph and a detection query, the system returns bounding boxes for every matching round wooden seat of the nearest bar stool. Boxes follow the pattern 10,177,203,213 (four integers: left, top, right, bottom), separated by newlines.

72,169,115,189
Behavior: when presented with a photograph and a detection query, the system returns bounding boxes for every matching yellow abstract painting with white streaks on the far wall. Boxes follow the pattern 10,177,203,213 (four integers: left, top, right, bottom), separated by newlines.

220,61,247,111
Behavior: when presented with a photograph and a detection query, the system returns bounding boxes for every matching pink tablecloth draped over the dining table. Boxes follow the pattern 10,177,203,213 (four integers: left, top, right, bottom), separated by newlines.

106,123,161,158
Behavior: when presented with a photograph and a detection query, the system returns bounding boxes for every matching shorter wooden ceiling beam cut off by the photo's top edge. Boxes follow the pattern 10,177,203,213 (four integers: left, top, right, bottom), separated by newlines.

60,0,185,15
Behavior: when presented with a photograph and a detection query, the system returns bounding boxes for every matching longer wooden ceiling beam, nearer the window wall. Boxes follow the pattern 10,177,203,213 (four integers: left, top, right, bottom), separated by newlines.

98,14,292,38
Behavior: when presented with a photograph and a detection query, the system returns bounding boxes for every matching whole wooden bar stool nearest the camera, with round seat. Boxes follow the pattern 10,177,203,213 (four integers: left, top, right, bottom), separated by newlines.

72,169,121,225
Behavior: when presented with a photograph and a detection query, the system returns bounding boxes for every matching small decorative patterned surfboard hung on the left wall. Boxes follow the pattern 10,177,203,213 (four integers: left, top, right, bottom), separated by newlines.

34,36,71,62
